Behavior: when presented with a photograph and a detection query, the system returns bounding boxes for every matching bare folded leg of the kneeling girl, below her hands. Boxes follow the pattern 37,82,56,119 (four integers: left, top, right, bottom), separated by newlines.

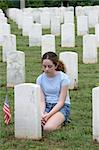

43,112,65,131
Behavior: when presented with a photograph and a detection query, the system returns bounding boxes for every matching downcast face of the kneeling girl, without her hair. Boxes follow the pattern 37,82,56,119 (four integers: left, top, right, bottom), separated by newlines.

42,59,56,76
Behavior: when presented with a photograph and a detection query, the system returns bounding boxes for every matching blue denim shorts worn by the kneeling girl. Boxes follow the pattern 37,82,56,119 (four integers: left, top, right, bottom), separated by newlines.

45,103,70,122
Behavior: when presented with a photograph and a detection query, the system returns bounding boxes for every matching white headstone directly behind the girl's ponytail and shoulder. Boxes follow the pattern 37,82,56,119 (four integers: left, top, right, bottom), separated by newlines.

59,52,78,89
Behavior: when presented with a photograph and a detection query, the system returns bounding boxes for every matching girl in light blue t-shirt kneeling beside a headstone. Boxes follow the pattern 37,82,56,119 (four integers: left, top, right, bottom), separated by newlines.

36,52,70,131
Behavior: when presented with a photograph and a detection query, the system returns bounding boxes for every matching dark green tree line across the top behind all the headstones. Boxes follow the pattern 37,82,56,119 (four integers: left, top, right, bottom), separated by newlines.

0,0,99,10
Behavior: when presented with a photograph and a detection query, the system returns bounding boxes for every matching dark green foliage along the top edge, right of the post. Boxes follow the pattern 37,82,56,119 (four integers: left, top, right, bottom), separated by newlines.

26,0,99,7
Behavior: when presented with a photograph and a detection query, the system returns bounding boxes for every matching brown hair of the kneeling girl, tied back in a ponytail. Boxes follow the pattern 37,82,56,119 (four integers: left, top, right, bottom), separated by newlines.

42,52,66,72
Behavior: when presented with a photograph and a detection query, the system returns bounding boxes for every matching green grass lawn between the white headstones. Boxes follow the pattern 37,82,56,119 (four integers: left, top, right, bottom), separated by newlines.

0,20,99,150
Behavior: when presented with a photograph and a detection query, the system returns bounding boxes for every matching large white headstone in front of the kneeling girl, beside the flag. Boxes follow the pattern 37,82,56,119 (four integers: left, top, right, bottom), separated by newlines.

14,83,42,140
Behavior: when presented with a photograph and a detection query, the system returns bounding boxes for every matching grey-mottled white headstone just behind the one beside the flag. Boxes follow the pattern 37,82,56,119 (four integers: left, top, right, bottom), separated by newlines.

7,51,25,87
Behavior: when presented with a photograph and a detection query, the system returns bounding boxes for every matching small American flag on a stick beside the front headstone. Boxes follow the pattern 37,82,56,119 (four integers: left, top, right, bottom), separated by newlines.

3,95,11,125
